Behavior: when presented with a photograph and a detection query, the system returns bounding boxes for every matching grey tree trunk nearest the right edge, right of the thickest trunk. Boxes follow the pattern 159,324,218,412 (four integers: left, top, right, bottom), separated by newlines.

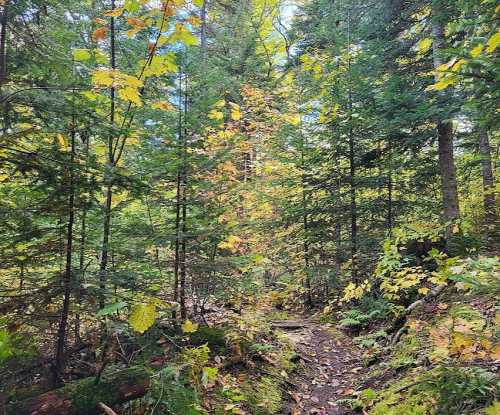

479,128,498,247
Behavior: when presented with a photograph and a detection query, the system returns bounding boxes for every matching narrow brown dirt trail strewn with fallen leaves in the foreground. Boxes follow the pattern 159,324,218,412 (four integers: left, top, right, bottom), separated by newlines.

282,320,364,415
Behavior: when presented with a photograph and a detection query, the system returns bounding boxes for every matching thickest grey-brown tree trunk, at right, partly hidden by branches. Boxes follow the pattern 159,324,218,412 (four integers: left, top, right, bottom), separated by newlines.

432,0,460,232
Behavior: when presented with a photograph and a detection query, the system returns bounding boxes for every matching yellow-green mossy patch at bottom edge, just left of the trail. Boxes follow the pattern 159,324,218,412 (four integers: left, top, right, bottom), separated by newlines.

242,376,283,415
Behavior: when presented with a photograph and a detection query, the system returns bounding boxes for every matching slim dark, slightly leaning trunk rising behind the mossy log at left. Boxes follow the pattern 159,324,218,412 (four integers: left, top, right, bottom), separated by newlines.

55,127,75,375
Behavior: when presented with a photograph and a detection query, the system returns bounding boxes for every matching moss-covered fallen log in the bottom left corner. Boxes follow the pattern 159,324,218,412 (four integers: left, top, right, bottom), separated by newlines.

6,367,150,415
